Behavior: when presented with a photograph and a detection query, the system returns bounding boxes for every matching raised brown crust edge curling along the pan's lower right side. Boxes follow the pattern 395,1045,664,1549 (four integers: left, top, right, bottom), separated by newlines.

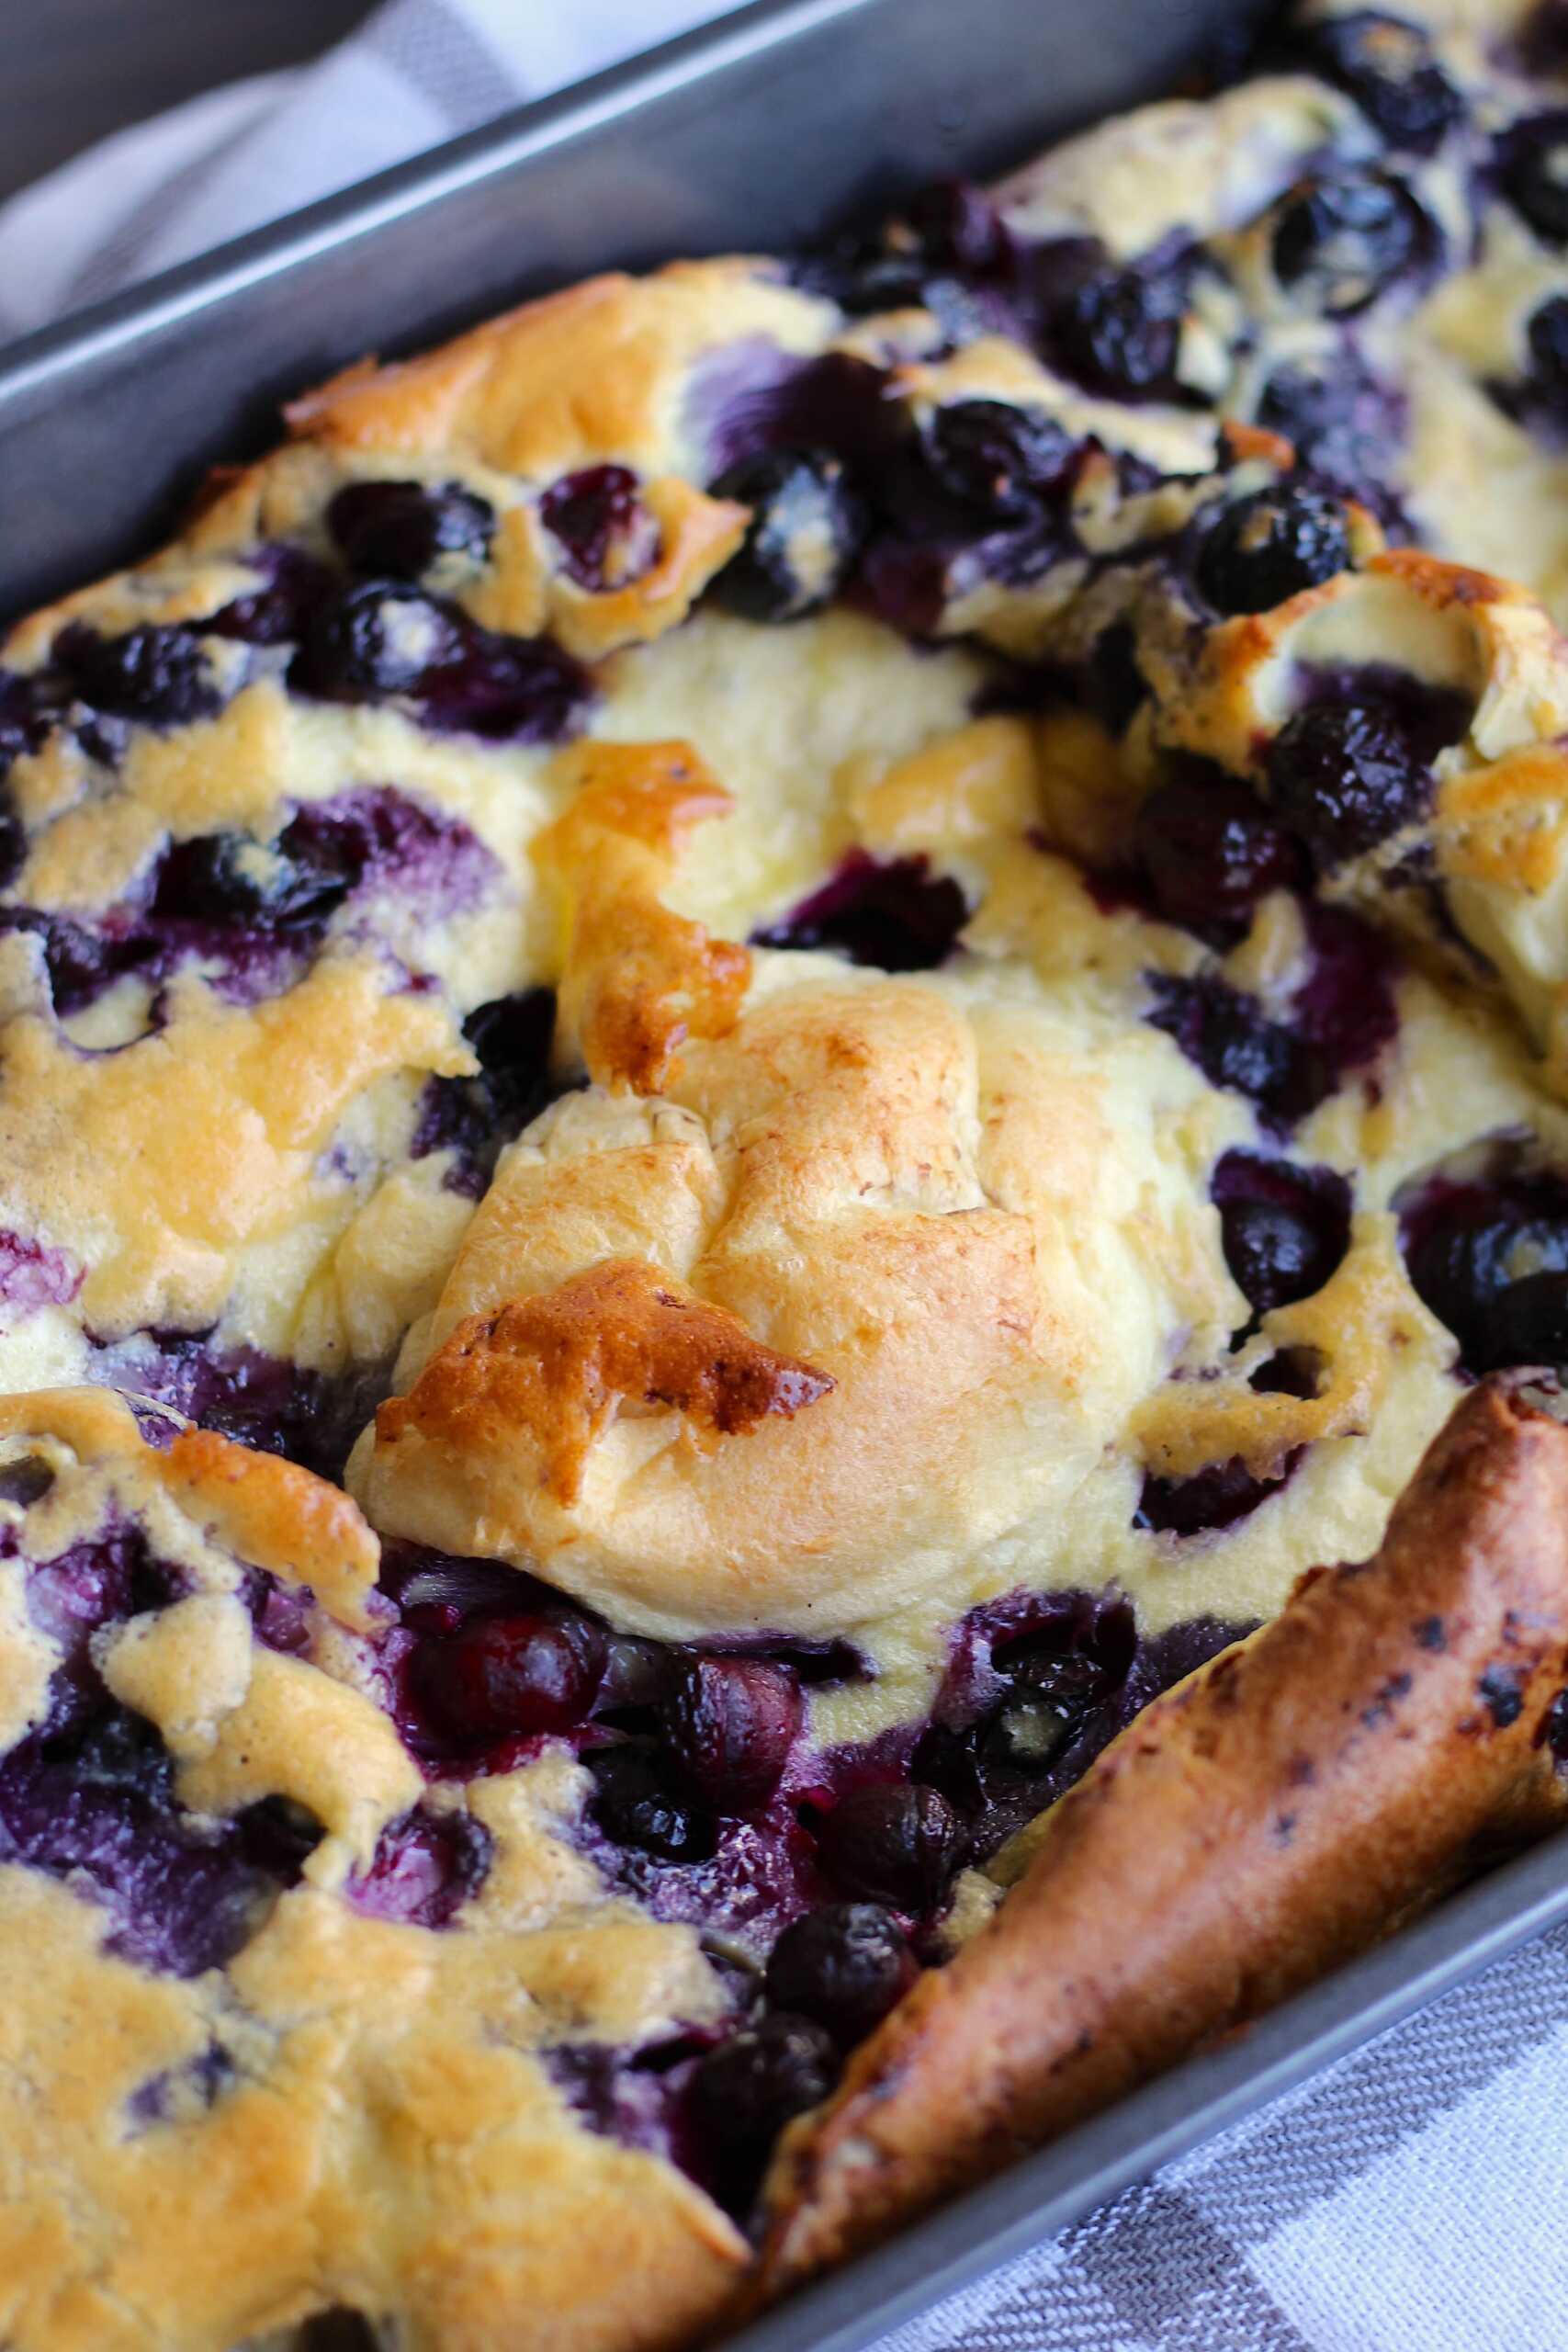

760,1385,1568,2296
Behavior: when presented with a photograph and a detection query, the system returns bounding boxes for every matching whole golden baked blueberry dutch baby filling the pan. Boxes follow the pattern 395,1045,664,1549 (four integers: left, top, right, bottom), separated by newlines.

12,0,1568,2352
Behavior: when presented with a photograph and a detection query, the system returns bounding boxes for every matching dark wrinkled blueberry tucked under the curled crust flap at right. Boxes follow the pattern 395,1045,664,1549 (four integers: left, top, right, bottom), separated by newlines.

1267,703,1432,865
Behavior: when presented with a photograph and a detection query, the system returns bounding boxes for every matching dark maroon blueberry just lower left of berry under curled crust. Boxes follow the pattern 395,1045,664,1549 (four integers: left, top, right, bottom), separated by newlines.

1134,772,1304,932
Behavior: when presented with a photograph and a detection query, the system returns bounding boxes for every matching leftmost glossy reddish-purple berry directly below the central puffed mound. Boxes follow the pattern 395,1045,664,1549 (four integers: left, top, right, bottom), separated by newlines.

413,1613,604,1747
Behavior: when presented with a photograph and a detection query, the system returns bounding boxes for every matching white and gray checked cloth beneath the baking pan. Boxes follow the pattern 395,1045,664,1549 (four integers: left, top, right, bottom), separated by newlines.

0,0,1568,2352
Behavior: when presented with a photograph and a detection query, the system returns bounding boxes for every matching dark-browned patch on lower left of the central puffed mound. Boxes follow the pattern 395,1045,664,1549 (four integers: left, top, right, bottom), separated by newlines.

376,1259,835,1510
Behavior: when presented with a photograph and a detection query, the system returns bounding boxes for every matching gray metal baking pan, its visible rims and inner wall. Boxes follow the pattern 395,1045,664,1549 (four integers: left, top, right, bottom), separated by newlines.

0,0,1568,2352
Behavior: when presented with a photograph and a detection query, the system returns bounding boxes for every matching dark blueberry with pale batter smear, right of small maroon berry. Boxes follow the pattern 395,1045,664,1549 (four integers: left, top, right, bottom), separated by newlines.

707,449,865,621
